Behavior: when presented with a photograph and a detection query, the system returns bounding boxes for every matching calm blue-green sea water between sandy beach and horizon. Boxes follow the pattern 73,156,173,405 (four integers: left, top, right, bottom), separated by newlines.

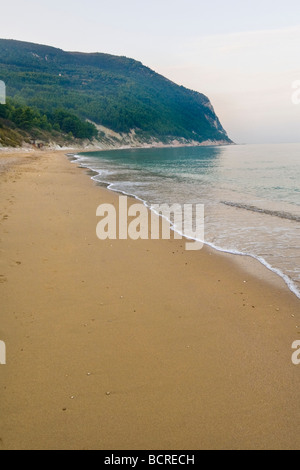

74,144,300,298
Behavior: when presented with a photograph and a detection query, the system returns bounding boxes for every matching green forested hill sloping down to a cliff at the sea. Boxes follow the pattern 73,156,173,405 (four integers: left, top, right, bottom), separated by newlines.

0,39,231,143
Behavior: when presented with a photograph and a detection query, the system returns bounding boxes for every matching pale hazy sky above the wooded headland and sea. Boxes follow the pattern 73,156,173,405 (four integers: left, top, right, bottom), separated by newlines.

0,0,300,143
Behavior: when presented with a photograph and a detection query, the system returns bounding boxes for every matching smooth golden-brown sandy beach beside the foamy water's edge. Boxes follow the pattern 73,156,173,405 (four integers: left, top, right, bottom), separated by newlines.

0,151,300,450
